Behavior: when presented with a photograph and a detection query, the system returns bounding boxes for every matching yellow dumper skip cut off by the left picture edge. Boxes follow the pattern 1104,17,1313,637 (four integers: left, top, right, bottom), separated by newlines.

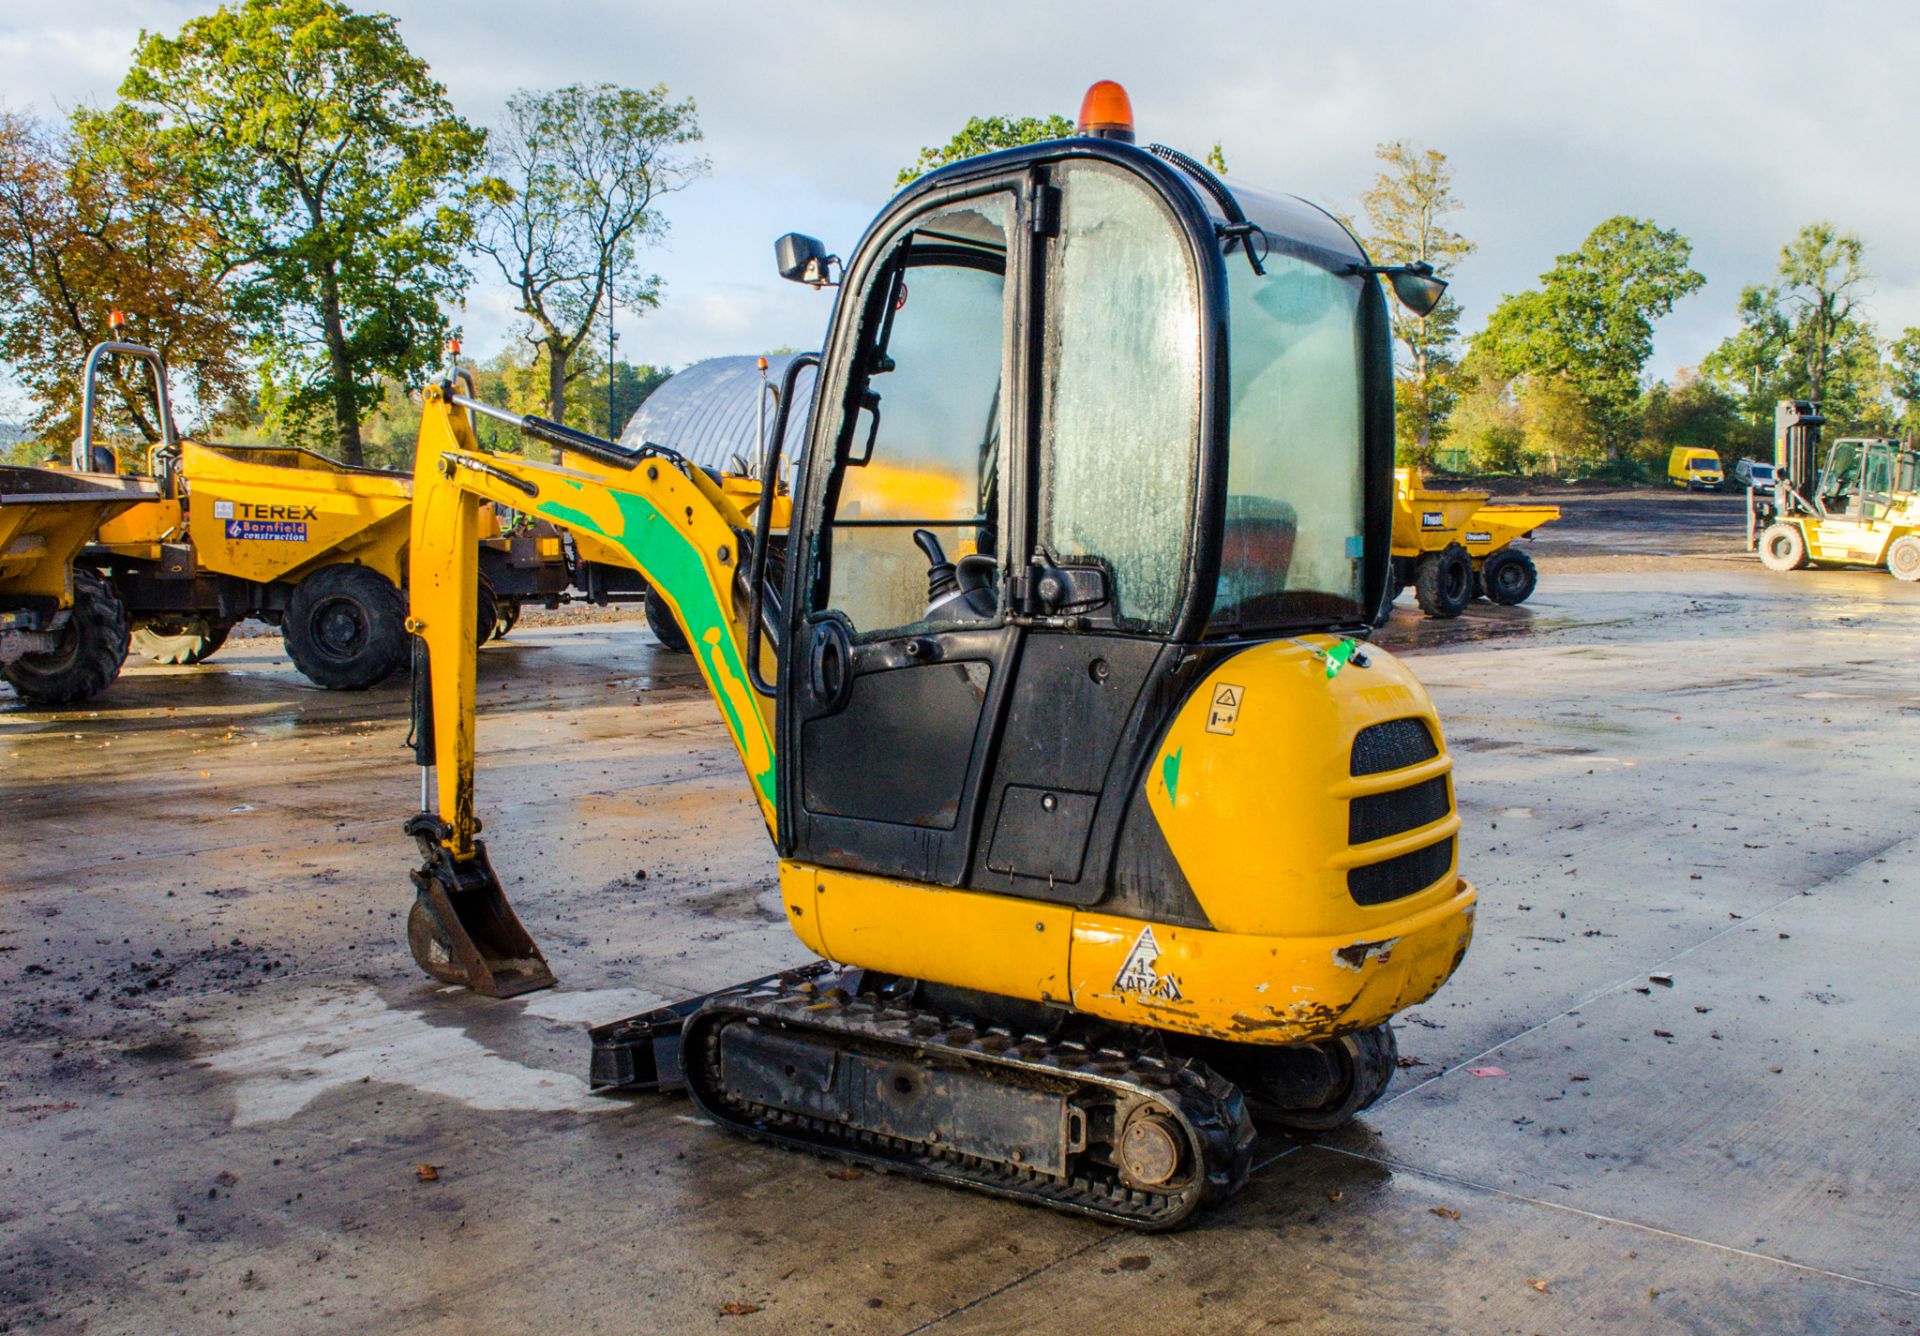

0,466,159,608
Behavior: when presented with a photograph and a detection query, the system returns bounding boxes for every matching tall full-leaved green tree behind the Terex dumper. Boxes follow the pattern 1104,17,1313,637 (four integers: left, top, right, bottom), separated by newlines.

121,0,486,463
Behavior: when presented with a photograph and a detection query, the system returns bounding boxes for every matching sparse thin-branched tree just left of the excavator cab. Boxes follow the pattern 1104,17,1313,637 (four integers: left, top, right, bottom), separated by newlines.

476,84,707,433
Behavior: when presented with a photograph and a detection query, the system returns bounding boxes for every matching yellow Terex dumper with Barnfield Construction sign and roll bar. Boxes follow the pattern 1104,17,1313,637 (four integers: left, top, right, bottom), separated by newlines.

73,342,568,691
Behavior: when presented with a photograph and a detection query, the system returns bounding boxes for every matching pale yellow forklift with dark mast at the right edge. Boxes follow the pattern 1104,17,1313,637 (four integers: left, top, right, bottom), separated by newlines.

1747,399,1920,580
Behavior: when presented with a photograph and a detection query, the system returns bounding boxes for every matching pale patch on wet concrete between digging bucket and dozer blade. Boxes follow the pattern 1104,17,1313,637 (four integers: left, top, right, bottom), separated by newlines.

200,987,606,1127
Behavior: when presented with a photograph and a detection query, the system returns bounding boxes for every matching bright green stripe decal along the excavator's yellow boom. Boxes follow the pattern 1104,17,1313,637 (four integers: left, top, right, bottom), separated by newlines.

534,491,774,802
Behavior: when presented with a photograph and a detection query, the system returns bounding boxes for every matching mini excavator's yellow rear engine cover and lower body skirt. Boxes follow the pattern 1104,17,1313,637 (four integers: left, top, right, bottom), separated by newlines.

780,637,1475,1044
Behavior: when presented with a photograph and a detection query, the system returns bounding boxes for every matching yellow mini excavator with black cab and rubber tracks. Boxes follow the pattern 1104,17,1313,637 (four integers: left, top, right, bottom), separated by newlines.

407,84,1475,1229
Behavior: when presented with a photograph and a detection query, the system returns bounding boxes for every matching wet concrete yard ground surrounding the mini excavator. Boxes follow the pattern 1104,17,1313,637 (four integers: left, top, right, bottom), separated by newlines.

0,493,1920,1336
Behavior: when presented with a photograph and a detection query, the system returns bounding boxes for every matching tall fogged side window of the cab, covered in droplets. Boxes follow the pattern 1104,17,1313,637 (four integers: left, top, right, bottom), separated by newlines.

1037,163,1200,630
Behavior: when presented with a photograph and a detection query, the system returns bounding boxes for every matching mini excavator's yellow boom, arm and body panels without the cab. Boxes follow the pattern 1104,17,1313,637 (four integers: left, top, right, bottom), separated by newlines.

409,388,1475,1044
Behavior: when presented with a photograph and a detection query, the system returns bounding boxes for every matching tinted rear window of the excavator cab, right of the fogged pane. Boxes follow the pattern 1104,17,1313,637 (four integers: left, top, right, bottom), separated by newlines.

1208,238,1365,633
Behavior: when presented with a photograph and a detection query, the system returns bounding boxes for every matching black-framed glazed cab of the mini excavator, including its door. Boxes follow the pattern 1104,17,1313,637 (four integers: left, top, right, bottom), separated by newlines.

780,140,1392,904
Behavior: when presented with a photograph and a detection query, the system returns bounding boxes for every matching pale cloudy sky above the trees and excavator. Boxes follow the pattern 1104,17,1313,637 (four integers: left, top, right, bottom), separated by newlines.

0,0,1920,385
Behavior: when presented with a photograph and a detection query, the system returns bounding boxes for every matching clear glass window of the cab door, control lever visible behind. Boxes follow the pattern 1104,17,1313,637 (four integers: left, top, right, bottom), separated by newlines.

816,196,1012,639
